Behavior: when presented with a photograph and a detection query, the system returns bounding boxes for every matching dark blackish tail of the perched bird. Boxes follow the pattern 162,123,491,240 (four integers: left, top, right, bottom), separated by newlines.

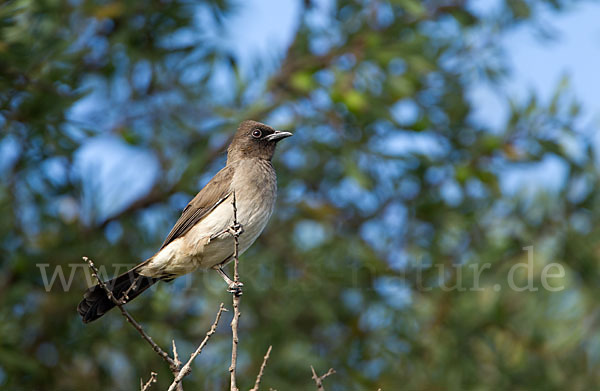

77,265,158,323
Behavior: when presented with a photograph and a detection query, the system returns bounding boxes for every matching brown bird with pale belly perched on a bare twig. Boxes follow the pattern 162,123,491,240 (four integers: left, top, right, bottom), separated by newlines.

77,120,292,323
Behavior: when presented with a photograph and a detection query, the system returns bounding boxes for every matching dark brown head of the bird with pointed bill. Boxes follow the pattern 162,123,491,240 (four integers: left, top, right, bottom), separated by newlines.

227,121,292,163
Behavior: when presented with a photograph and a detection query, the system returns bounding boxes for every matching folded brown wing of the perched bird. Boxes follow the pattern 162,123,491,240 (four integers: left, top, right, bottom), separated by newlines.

160,166,233,250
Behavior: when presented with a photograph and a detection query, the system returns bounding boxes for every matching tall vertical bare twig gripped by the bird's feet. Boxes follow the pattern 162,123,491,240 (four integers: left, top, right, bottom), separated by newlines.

229,192,243,391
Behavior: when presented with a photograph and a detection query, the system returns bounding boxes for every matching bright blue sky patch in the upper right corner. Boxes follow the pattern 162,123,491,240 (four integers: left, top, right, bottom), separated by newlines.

474,1,600,131
